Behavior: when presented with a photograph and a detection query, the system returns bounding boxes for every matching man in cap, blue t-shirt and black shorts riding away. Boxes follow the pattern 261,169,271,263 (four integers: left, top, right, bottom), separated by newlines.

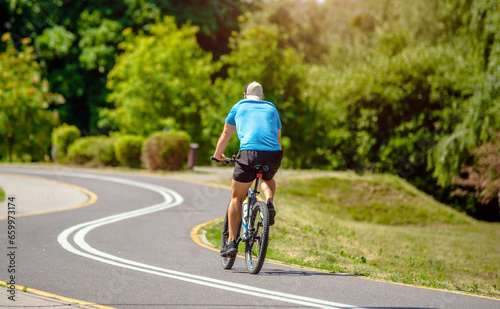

214,81,283,256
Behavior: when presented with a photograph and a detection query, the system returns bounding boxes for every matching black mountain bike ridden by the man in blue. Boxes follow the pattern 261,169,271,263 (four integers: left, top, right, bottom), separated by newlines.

211,156,269,274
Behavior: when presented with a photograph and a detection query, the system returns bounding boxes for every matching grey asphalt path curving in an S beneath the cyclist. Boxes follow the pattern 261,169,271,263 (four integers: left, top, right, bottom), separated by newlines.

0,167,500,309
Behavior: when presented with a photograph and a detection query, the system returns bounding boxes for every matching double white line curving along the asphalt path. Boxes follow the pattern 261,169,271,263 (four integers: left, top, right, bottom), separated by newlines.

10,171,363,309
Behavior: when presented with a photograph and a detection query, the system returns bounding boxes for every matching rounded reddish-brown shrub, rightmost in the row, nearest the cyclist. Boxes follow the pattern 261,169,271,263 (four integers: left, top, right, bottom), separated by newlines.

142,131,191,171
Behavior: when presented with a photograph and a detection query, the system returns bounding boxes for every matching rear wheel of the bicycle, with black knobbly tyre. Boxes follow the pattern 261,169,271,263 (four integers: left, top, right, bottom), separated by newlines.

245,201,269,274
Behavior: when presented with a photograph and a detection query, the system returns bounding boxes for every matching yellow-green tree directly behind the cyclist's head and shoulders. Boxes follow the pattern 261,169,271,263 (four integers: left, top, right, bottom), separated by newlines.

218,26,330,168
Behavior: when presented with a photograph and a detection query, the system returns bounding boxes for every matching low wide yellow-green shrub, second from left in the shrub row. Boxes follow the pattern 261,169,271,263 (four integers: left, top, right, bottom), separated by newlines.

67,136,118,166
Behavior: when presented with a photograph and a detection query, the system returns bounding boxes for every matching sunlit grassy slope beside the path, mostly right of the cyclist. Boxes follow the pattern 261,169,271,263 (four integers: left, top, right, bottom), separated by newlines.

203,172,500,297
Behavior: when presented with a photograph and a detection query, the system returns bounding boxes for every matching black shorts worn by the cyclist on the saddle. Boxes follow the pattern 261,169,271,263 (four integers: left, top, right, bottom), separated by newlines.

233,150,283,182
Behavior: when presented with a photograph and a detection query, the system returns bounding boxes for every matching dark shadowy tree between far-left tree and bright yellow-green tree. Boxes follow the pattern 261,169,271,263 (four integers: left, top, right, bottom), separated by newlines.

5,0,133,135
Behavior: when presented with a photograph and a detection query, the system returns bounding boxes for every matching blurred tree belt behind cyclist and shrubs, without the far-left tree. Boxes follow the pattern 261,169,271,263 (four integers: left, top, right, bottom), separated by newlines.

0,0,500,221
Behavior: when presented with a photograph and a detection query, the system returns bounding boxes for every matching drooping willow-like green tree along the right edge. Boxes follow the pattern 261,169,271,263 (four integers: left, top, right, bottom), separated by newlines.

430,0,500,186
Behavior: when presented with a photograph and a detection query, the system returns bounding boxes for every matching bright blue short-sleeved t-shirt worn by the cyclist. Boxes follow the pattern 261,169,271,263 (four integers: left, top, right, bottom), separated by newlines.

226,99,281,151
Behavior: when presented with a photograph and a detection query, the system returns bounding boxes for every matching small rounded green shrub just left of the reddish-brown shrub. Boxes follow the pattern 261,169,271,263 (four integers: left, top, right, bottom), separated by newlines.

115,135,144,168
